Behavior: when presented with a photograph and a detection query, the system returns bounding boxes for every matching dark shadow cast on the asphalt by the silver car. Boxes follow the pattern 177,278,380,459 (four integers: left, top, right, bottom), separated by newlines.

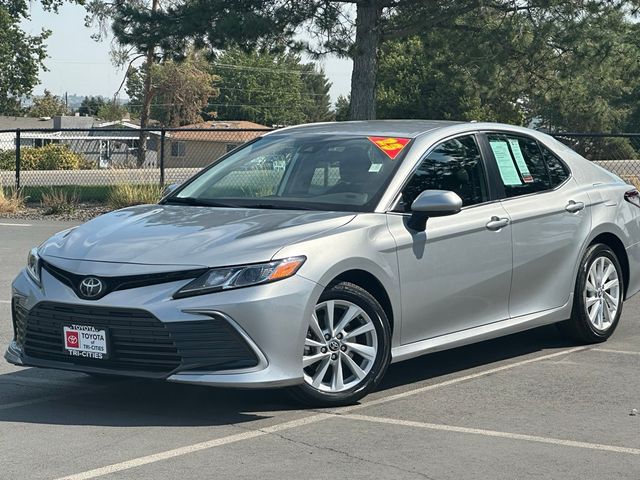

0,326,571,427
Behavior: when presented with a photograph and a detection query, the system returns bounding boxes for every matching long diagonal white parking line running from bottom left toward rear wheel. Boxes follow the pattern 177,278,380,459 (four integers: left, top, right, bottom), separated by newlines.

51,346,589,480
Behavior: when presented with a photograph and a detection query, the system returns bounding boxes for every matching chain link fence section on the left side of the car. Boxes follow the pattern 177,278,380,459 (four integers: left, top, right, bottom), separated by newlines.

0,128,269,200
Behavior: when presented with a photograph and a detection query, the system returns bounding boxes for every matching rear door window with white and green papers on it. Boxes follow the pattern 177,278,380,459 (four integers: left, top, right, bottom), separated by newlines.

487,134,552,197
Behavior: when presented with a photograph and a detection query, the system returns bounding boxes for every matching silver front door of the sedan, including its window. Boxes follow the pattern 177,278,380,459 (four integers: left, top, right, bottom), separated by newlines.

387,135,512,344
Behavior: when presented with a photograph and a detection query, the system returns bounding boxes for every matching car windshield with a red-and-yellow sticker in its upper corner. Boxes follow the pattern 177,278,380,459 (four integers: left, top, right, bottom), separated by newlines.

165,134,409,211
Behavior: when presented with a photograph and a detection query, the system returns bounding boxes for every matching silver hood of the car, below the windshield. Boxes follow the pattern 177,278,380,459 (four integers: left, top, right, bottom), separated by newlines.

39,205,355,267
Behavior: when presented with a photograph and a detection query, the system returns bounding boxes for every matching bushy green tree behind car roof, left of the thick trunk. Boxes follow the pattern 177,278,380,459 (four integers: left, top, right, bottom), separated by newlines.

211,48,332,126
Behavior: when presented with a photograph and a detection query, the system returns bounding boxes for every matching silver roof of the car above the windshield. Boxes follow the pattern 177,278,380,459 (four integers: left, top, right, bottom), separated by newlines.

269,120,468,138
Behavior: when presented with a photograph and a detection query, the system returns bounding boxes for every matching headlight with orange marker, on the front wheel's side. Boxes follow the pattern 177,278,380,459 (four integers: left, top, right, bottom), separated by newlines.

173,257,307,298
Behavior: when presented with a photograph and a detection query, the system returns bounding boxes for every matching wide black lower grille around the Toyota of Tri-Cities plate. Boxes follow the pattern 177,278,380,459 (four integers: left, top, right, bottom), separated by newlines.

12,301,258,377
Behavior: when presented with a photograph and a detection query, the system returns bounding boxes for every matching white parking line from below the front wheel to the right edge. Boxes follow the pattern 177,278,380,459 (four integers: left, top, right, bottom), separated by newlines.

343,414,640,455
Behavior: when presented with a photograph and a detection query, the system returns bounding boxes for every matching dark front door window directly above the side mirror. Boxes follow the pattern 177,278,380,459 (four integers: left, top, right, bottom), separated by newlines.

402,136,488,212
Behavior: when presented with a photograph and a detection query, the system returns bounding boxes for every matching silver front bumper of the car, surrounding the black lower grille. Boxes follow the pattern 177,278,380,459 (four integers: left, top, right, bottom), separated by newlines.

5,262,322,388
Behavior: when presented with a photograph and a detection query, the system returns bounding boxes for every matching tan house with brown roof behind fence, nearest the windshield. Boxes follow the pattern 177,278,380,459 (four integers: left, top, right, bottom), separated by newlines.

164,120,269,168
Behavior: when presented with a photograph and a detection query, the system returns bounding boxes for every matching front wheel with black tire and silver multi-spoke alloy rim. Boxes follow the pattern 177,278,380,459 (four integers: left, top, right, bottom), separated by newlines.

291,282,391,407
